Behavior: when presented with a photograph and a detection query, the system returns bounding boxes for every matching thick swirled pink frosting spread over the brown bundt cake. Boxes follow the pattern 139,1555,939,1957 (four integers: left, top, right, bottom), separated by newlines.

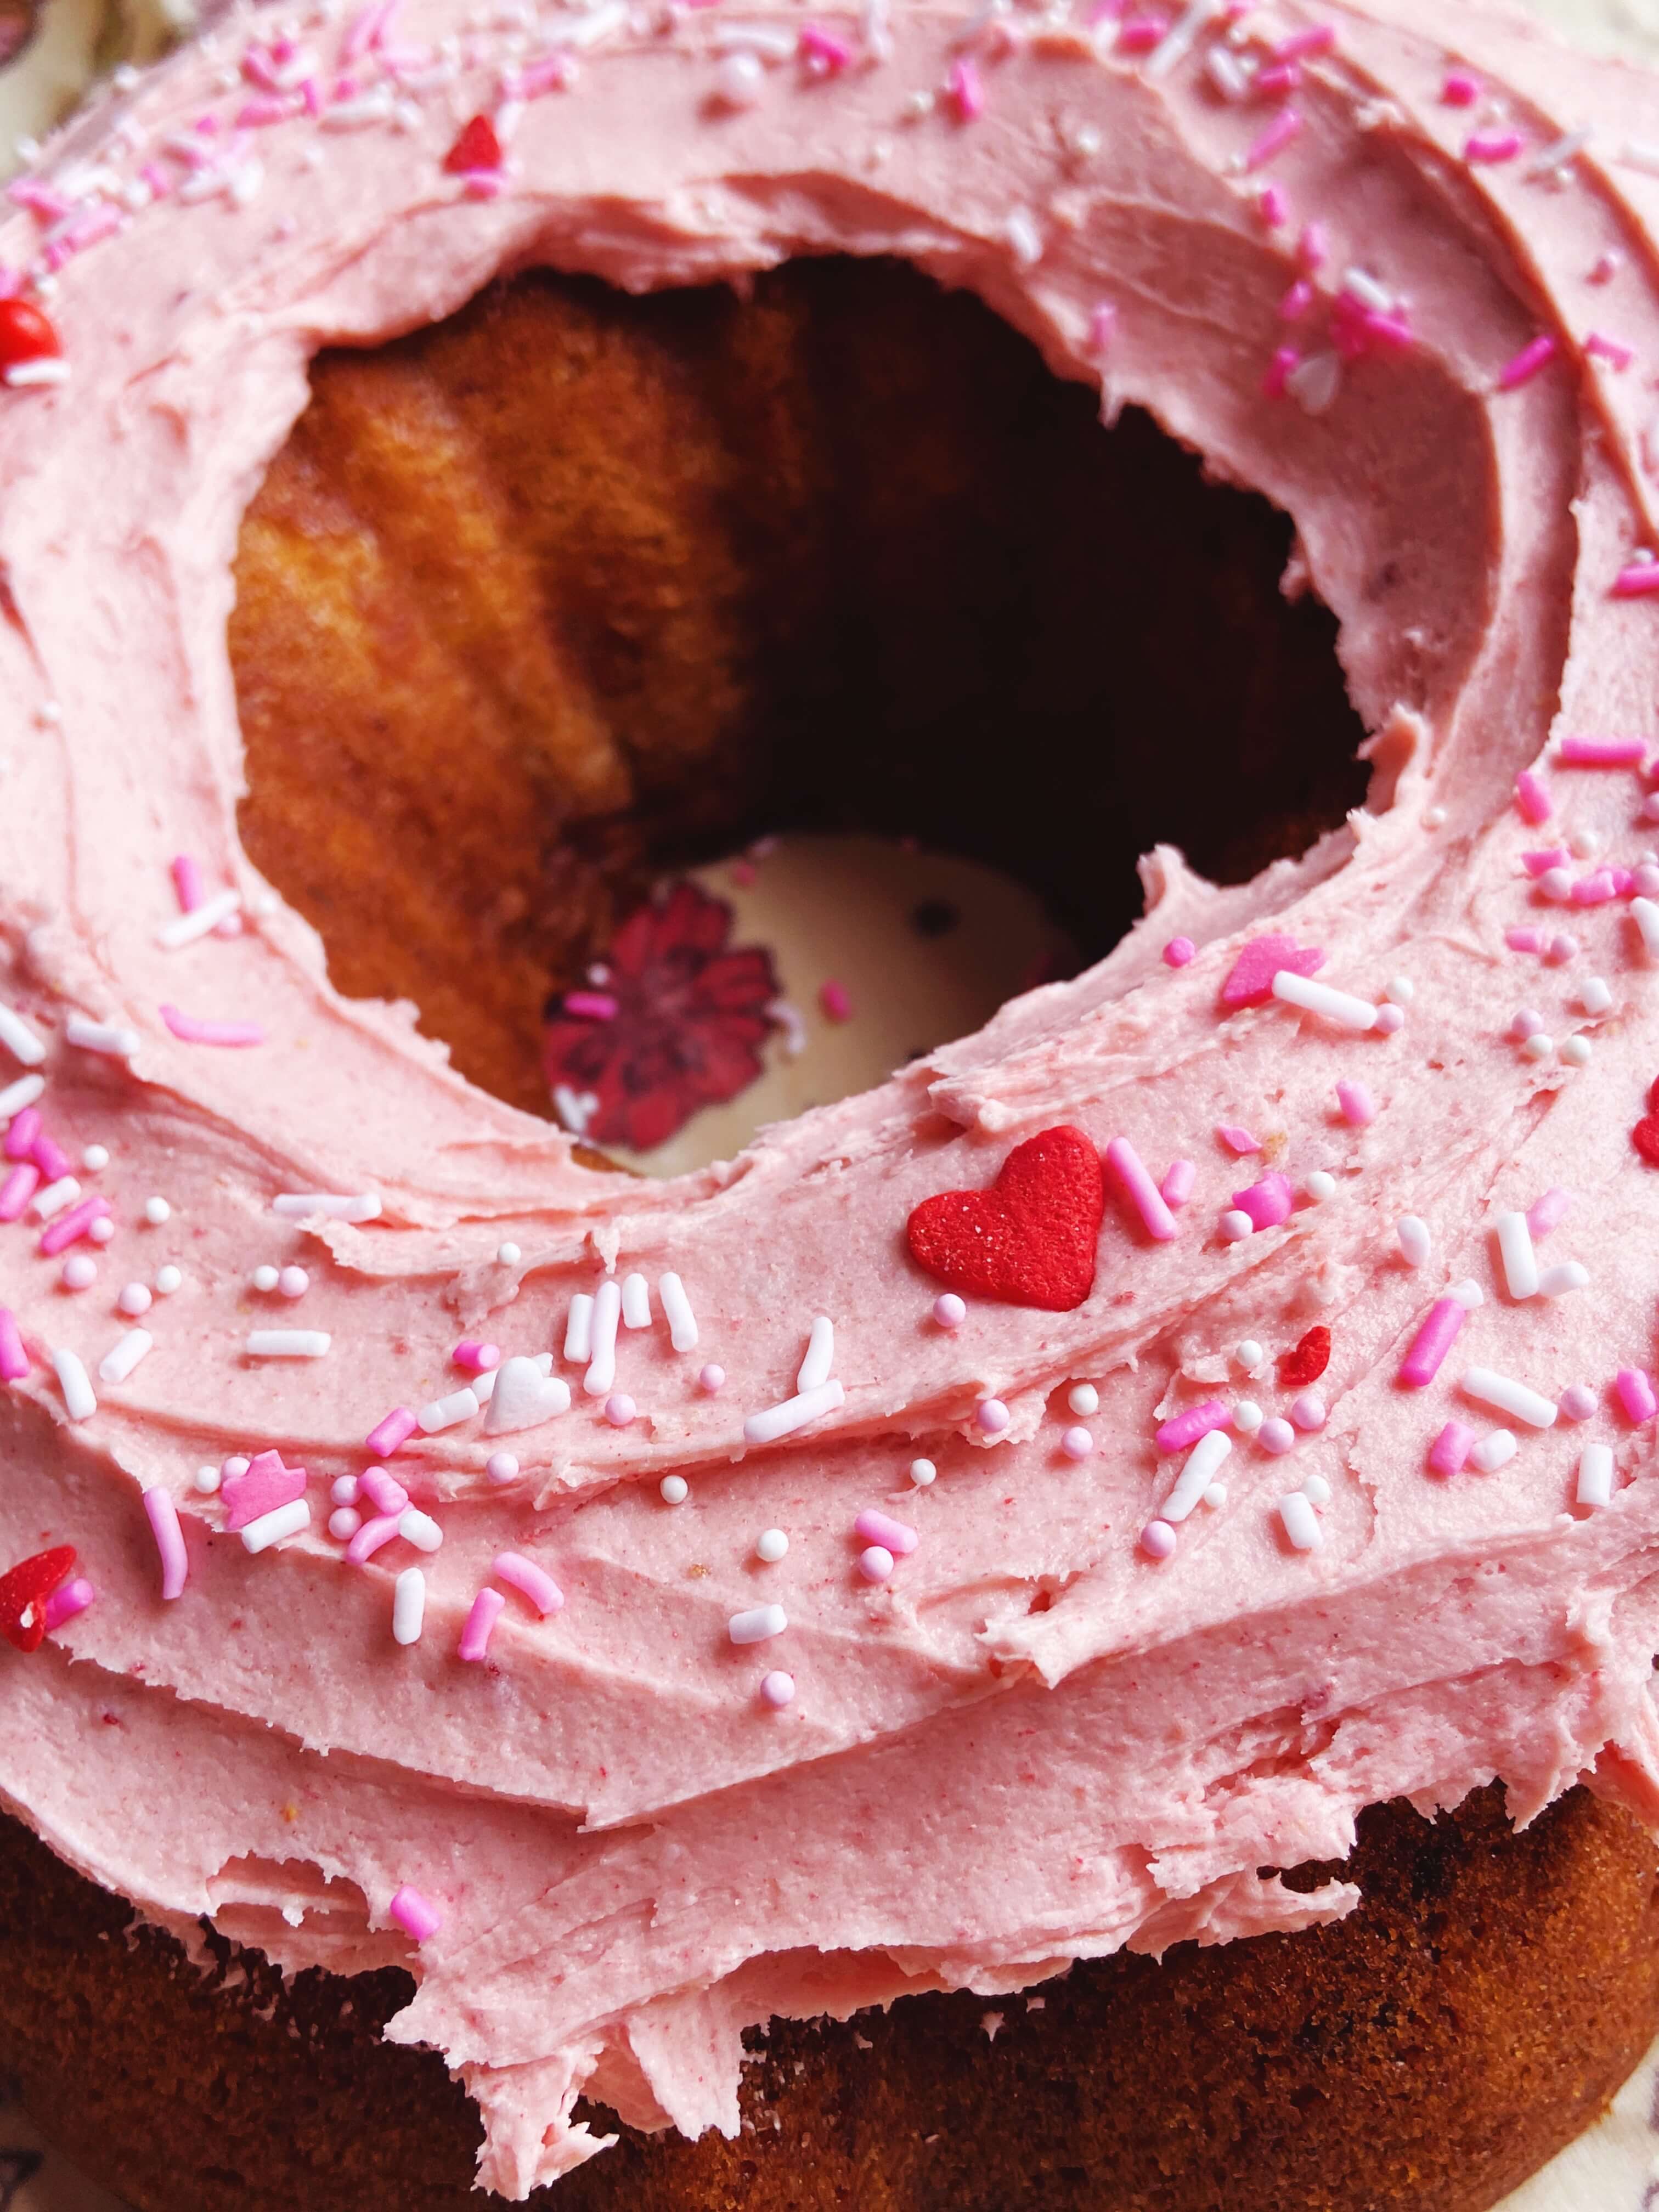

0,0,1659,2197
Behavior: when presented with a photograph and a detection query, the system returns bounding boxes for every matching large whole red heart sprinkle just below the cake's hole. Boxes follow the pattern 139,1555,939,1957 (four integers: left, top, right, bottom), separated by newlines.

905,1128,1106,1314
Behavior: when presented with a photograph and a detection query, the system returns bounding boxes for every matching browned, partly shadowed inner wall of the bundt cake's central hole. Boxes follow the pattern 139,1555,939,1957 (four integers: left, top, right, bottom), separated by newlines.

230,259,1365,1166
